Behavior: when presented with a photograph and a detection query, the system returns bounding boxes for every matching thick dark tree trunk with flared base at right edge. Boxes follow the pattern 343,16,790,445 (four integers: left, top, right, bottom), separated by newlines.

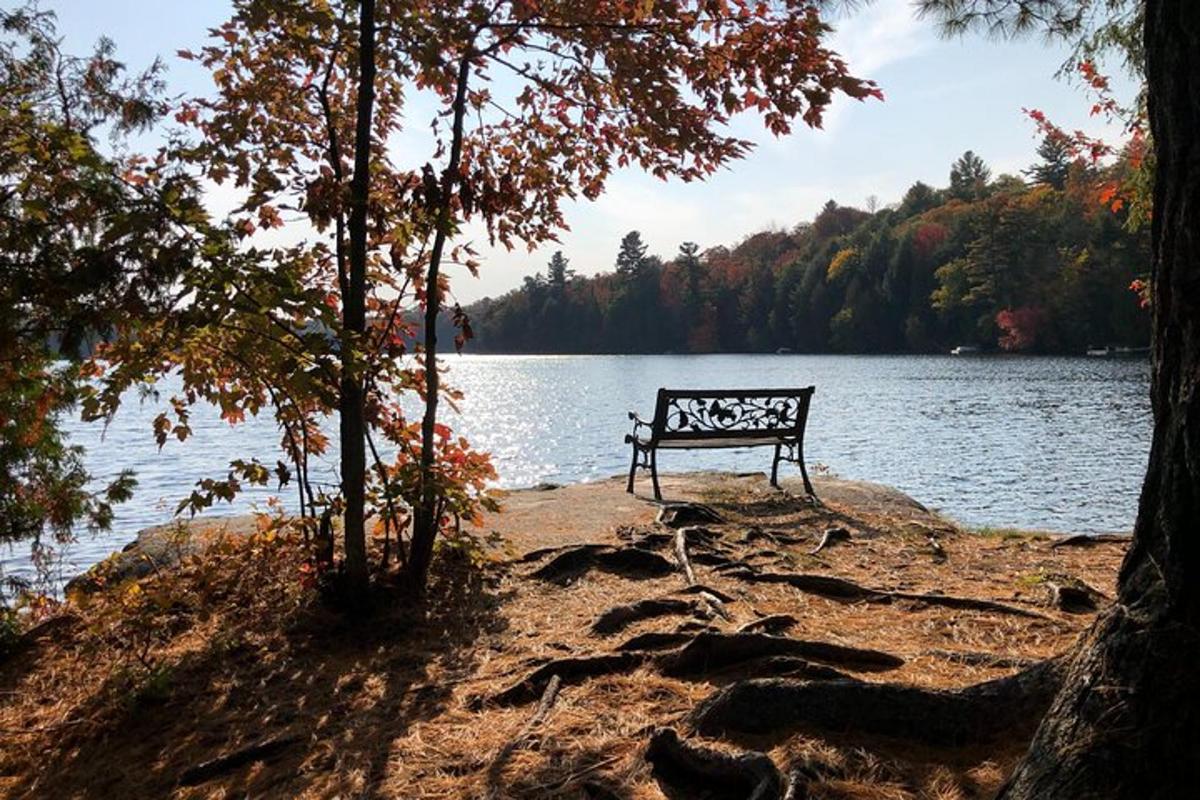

1001,0,1200,800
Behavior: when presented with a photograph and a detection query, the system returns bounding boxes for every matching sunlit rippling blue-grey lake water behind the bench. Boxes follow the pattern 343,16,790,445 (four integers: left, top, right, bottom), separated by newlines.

0,355,1151,585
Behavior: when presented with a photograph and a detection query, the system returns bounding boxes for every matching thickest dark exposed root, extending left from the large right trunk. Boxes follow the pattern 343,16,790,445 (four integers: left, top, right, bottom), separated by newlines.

692,658,1063,746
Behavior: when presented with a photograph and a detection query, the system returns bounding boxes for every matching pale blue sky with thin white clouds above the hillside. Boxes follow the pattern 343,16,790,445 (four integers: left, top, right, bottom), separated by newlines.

42,0,1133,302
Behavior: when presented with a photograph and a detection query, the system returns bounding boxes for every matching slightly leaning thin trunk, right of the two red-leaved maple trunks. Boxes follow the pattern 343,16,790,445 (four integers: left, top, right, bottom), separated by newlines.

408,50,470,593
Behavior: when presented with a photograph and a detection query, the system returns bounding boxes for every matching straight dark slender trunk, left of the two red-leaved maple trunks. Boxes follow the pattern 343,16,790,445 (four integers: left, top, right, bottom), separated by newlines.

338,0,376,602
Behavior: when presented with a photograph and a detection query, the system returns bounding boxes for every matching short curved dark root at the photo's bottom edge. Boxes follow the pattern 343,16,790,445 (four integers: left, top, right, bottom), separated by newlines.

646,728,784,800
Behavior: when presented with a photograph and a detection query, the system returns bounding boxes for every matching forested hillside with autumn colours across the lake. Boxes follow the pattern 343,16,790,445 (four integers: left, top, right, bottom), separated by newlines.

468,146,1150,353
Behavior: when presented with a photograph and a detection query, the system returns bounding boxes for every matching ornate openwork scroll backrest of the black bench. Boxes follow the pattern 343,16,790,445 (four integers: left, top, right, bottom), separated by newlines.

652,386,815,441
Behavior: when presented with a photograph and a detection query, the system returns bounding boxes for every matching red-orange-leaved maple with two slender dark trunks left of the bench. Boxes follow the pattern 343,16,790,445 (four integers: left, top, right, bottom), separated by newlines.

91,0,878,599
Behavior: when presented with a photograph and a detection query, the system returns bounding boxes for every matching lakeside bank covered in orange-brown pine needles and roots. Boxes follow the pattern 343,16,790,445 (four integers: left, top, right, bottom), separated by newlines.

0,473,1124,798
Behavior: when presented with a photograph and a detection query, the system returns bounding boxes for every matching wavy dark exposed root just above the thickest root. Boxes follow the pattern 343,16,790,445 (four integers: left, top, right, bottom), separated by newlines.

660,633,904,676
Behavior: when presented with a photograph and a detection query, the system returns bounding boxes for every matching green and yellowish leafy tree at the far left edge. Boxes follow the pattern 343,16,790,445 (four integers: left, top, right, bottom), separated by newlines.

0,5,203,582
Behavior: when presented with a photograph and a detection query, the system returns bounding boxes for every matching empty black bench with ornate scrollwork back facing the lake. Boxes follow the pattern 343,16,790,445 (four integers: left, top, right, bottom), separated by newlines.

625,386,816,500
